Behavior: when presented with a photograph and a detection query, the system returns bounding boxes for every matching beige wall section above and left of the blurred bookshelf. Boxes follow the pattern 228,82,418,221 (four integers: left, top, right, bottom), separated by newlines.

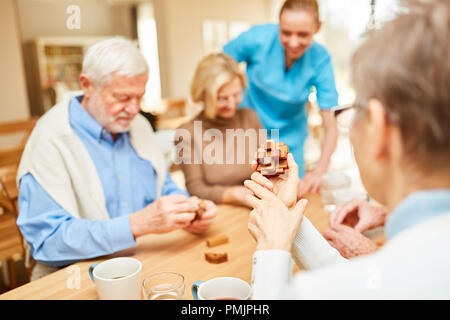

16,0,135,115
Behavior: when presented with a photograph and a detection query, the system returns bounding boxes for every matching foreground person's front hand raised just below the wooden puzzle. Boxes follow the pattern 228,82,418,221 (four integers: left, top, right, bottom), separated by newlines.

244,180,308,252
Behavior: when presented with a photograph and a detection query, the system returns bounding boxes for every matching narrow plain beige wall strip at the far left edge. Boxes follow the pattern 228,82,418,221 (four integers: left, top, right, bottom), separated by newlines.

0,0,29,122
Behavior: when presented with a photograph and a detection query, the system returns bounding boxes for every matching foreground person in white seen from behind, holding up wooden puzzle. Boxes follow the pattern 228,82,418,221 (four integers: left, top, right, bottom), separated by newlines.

245,0,450,299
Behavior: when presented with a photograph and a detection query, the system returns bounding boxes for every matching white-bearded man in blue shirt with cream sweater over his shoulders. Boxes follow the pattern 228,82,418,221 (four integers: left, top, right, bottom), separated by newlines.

17,38,216,280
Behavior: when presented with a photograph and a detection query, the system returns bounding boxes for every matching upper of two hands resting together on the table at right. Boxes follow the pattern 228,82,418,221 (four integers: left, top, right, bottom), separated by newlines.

330,199,387,233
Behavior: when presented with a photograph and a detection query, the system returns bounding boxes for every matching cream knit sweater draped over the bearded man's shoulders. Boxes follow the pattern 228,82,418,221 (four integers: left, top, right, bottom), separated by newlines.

16,100,166,278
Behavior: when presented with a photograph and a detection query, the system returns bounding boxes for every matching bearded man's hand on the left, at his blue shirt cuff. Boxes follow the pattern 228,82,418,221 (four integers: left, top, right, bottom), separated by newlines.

130,194,196,238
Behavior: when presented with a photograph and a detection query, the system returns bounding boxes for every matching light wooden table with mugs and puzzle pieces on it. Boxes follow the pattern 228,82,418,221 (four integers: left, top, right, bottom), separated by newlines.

0,194,386,300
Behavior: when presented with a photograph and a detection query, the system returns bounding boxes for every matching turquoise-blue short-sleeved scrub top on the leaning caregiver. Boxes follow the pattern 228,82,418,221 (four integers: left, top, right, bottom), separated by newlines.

223,24,338,177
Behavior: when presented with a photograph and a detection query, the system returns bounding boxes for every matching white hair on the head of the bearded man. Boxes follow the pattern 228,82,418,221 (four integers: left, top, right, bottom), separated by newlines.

82,37,149,86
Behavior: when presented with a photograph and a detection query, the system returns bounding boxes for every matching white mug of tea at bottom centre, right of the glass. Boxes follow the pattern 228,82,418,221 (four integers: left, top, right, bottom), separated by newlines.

192,277,251,300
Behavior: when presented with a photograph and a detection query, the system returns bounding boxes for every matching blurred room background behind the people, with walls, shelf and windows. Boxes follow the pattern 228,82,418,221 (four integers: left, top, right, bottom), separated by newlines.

0,0,406,291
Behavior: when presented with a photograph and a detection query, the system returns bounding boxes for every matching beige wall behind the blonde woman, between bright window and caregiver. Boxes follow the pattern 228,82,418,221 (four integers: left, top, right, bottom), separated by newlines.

153,0,271,98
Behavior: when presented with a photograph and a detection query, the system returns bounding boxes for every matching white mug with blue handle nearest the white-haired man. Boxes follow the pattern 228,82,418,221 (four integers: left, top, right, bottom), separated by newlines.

89,257,142,300
